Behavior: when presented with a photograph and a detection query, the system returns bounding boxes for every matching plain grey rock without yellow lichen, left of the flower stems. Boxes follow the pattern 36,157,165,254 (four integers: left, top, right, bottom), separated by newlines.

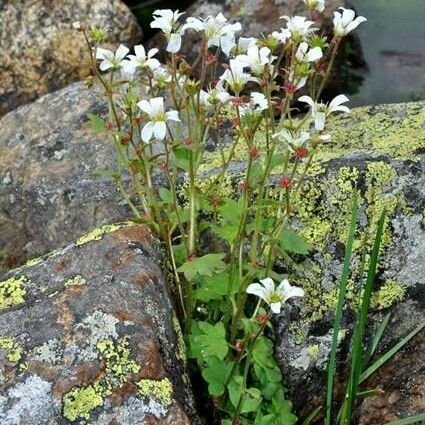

0,83,131,272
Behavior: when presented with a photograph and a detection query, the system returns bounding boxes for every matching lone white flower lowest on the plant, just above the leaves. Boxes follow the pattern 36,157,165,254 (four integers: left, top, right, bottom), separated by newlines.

246,277,304,314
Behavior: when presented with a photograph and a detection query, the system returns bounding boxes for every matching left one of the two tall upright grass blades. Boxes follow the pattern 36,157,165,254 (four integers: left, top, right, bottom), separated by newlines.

325,190,358,425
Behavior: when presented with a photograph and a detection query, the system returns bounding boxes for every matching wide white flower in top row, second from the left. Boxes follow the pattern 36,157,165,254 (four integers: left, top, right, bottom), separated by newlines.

183,13,242,55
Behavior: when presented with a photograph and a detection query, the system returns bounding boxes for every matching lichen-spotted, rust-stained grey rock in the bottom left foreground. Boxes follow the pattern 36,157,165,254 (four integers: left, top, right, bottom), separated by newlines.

0,223,196,425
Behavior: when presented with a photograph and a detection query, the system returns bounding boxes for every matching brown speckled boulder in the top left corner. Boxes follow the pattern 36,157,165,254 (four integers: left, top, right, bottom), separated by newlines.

0,0,142,116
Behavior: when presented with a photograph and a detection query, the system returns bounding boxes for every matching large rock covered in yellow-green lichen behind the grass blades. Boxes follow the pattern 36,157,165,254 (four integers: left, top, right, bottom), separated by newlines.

195,102,425,418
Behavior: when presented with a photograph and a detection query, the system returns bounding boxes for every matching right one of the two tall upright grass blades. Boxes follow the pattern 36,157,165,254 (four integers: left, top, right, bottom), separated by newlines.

342,210,386,425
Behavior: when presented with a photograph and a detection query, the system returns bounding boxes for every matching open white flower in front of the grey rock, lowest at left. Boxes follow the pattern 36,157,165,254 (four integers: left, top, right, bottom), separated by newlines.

137,97,180,143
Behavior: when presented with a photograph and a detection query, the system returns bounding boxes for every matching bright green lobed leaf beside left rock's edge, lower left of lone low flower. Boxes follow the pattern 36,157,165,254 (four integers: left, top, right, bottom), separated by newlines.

192,322,229,360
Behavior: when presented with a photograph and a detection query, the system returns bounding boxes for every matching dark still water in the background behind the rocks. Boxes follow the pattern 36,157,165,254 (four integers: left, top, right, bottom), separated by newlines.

126,0,425,106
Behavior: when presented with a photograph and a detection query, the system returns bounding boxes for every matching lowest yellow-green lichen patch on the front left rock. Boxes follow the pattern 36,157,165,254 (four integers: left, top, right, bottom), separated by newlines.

63,383,103,421
